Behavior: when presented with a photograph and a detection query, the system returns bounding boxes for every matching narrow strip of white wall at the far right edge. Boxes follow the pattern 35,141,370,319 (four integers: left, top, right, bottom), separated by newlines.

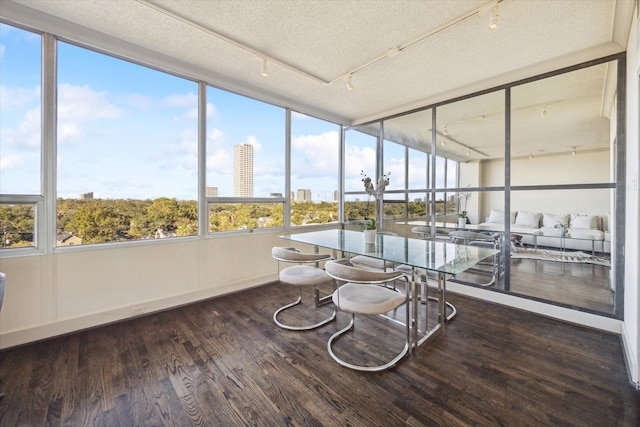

622,6,640,388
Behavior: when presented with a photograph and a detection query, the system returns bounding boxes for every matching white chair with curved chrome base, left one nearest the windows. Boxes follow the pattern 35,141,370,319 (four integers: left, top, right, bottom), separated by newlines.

271,246,336,331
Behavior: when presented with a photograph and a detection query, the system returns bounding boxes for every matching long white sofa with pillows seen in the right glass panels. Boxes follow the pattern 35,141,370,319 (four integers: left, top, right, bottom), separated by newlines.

478,209,611,253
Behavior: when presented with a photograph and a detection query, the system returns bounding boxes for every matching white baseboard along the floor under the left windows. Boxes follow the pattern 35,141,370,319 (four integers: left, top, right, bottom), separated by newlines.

0,274,273,350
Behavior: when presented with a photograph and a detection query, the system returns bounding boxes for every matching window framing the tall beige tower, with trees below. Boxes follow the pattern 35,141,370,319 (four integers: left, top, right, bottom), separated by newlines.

206,83,286,232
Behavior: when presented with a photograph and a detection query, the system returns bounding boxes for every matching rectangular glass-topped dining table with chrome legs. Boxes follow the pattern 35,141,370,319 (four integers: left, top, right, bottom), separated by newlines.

280,229,498,351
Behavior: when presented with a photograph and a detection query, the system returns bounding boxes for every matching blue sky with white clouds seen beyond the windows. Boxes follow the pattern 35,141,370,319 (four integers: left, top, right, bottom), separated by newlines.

0,25,424,200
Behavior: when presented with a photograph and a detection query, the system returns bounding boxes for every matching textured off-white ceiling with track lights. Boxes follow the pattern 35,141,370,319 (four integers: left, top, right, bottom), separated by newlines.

0,0,634,159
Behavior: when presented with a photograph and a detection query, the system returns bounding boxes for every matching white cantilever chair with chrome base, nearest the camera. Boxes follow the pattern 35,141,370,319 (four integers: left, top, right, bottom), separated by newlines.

325,259,411,371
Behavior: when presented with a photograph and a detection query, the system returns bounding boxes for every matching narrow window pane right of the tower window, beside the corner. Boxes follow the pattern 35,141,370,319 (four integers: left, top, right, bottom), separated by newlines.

291,113,340,226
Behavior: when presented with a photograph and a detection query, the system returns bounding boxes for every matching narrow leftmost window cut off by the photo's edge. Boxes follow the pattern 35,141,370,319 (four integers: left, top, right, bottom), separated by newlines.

0,24,42,249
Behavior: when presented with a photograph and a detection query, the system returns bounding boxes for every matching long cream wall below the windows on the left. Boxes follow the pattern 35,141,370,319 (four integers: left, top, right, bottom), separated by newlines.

0,230,296,348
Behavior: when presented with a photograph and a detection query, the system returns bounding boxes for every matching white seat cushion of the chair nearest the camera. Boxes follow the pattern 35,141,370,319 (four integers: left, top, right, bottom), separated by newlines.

332,283,406,314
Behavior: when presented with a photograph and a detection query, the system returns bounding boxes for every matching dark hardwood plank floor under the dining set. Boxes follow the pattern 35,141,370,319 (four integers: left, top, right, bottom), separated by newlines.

0,284,640,426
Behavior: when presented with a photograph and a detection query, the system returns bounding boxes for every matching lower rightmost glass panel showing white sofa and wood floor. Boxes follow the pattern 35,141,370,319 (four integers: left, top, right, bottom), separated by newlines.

510,189,616,313
